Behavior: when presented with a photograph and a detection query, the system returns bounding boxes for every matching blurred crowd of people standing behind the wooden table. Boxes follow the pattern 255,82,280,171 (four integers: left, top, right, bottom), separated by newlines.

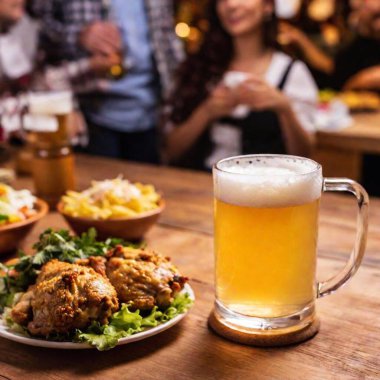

0,0,380,192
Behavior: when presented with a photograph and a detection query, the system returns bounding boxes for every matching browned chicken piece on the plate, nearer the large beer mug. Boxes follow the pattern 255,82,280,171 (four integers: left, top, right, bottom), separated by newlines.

107,246,188,310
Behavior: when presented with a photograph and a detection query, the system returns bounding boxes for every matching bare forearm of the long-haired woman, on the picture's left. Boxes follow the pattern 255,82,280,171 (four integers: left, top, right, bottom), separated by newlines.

165,105,211,161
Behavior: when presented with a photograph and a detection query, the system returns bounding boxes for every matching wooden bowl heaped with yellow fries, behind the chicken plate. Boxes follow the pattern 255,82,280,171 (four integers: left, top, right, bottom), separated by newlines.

57,177,165,240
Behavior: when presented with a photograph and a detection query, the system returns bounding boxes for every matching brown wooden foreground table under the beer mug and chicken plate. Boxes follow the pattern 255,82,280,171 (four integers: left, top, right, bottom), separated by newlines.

0,156,380,380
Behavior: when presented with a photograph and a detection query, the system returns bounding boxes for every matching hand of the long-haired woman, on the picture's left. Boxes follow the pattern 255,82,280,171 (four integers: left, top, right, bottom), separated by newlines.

204,85,237,121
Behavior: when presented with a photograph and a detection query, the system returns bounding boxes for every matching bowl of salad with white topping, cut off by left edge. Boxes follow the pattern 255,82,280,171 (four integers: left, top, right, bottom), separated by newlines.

0,184,49,254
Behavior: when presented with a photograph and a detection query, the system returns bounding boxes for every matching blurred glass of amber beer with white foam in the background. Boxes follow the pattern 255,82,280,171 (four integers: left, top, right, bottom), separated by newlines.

24,92,74,208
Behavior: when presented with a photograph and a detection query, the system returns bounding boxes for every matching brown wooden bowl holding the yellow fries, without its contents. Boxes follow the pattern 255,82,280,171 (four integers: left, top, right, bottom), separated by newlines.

57,199,165,240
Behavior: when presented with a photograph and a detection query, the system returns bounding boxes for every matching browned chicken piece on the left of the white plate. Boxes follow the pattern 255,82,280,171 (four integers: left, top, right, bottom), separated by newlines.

12,260,119,337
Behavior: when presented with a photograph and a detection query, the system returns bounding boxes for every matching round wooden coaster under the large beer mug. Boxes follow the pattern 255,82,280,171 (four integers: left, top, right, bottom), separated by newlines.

208,311,320,347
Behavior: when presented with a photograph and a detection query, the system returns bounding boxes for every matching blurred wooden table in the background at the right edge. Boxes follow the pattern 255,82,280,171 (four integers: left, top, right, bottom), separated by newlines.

314,112,380,181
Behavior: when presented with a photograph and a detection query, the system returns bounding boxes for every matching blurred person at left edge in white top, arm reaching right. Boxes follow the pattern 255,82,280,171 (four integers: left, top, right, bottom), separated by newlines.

0,0,116,92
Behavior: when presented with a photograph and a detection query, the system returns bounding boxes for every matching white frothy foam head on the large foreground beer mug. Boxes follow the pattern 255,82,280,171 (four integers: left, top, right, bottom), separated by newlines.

214,155,322,207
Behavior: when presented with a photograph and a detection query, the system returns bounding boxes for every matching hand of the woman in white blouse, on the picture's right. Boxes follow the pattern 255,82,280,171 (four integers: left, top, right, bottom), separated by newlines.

236,76,290,112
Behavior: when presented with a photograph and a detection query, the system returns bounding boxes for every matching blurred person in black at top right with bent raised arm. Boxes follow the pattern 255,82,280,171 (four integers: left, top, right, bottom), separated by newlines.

280,0,380,90
